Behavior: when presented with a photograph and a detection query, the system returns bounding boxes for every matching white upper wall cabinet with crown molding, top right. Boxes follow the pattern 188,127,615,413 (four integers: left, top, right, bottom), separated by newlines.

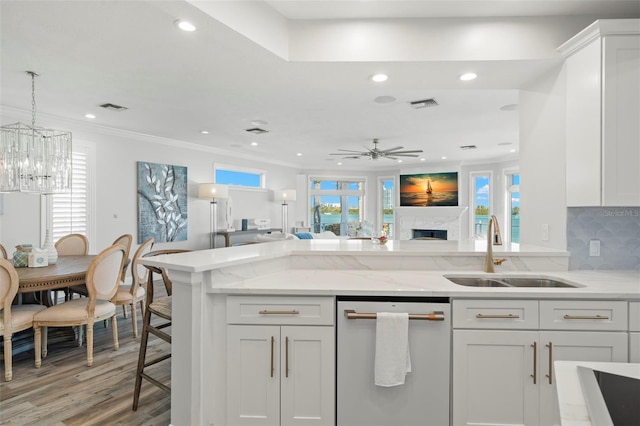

559,19,640,206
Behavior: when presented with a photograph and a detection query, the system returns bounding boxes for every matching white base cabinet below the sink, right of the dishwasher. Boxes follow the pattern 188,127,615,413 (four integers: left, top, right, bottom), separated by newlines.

453,300,627,426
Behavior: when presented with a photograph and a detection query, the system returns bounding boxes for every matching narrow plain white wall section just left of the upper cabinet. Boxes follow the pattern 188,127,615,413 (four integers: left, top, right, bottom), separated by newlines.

520,66,567,250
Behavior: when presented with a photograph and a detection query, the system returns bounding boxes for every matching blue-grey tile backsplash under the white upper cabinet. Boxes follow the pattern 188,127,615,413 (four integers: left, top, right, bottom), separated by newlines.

567,207,640,270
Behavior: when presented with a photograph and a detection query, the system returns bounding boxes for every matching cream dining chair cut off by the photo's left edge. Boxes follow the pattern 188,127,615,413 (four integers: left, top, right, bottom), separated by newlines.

0,259,46,382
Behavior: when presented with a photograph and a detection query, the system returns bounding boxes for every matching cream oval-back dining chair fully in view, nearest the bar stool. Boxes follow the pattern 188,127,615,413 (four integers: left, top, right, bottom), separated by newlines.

33,245,124,368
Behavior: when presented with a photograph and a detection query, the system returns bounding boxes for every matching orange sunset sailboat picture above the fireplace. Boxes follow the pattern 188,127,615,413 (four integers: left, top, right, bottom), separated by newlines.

400,172,458,207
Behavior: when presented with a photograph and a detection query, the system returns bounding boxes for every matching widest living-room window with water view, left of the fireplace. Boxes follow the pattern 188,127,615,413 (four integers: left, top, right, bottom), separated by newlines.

309,178,364,235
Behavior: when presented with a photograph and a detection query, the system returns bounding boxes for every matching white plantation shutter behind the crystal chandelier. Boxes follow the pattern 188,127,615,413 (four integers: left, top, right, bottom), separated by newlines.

50,147,88,241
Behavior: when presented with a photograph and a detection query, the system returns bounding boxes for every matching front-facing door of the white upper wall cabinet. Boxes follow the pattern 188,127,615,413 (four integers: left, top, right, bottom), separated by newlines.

602,35,640,206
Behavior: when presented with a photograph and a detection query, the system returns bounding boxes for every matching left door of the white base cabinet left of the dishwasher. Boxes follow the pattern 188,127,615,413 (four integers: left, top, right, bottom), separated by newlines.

227,325,280,426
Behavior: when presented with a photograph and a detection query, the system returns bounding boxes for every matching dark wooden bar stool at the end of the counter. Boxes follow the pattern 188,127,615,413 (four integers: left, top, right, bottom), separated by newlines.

132,249,189,411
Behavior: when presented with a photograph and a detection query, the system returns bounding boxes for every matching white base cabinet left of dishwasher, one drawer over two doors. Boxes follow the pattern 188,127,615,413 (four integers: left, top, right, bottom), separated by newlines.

227,296,335,426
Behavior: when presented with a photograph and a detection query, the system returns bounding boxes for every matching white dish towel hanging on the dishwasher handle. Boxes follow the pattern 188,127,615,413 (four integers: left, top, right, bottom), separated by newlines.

374,312,411,387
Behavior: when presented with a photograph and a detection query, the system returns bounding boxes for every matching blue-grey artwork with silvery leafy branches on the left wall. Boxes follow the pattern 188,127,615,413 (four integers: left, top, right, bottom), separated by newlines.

138,161,188,244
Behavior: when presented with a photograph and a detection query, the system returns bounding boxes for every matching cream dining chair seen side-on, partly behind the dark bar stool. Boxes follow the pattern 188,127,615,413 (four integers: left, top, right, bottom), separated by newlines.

111,237,155,337
